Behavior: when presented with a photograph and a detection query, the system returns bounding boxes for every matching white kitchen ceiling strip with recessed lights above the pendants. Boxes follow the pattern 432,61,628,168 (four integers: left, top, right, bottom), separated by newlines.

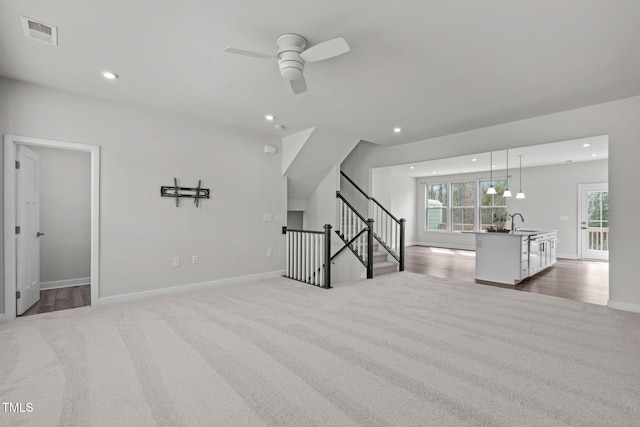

389,135,609,178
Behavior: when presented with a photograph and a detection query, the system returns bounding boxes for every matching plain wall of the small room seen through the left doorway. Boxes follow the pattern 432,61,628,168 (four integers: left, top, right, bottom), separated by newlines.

29,147,91,283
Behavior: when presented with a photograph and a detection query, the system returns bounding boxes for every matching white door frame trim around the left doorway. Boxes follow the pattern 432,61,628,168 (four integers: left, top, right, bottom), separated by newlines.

4,135,100,321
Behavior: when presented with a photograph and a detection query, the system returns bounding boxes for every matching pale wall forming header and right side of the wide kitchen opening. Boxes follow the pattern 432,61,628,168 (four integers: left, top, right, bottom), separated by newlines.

342,97,640,311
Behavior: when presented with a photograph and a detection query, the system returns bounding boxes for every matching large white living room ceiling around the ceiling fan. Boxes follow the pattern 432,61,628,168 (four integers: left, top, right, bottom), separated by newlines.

0,0,640,145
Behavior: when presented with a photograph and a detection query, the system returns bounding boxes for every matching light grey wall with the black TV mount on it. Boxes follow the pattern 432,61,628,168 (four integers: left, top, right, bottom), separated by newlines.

0,79,287,304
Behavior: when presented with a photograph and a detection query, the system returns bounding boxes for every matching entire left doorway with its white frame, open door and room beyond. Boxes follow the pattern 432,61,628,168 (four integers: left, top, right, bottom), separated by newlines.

4,135,100,320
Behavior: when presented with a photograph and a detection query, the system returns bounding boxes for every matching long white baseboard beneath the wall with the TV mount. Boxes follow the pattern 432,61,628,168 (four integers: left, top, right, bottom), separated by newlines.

98,270,285,307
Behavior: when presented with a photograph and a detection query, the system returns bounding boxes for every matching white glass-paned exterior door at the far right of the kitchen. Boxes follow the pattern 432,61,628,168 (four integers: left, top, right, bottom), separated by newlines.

579,184,609,261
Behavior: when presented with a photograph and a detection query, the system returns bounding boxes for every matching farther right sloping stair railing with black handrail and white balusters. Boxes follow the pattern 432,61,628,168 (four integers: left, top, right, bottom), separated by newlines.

340,171,406,271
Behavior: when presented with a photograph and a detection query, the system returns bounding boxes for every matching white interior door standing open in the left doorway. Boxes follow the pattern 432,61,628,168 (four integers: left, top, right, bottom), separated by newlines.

16,145,40,315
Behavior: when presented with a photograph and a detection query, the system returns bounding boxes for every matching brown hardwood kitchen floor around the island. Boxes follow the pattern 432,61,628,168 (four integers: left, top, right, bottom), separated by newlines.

405,246,609,305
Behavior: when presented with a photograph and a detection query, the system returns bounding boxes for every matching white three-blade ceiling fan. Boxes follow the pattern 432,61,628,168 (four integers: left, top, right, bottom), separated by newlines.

224,33,351,95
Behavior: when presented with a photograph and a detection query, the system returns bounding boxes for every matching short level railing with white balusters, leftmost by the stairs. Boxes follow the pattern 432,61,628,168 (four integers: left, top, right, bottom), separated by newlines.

284,224,332,289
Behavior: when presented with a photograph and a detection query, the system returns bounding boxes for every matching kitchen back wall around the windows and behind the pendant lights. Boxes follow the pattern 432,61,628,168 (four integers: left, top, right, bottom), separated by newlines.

415,160,608,258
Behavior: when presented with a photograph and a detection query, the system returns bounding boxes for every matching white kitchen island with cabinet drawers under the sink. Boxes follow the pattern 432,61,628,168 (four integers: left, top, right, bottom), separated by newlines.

475,230,557,285
